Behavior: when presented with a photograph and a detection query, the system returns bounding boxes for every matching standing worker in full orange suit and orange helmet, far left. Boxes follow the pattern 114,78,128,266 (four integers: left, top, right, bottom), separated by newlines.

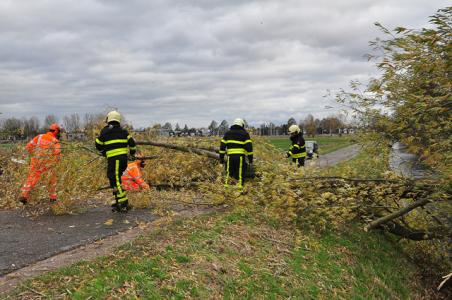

19,124,61,204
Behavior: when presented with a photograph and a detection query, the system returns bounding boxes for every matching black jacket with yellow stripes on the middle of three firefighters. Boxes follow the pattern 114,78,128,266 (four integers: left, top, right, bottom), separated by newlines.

219,125,253,163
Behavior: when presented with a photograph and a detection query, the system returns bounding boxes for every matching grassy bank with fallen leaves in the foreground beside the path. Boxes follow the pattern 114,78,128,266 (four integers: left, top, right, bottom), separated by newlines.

8,213,424,299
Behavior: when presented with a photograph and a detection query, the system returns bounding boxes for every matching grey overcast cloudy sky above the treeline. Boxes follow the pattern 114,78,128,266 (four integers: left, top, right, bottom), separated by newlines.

0,0,450,126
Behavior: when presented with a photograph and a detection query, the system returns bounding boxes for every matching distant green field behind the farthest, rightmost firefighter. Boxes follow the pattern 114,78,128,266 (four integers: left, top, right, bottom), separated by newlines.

268,135,354,155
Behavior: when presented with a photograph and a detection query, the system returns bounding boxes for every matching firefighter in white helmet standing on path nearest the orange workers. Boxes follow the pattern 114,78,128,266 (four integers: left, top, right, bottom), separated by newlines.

96,110,136,212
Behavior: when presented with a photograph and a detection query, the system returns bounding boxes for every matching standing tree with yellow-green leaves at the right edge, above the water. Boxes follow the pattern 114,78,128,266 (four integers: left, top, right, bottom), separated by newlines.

336,7,452,170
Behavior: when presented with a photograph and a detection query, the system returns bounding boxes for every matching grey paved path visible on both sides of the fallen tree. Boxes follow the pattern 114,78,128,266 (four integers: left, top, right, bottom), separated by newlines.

0,145,360,277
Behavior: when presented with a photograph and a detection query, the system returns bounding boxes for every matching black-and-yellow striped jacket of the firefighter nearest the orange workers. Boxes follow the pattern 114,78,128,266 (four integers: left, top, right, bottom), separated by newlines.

96,123,137,158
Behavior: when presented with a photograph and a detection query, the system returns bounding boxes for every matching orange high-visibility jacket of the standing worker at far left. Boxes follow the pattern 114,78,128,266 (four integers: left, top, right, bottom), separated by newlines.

25,132,61,164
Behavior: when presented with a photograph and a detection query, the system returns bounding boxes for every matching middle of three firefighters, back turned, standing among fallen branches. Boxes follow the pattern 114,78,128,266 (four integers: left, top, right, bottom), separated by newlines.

220,119,253,188
